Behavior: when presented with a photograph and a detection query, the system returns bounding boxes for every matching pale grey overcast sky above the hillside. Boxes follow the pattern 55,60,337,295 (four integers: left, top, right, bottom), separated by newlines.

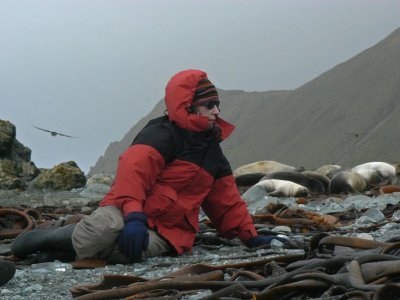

0,0,400,173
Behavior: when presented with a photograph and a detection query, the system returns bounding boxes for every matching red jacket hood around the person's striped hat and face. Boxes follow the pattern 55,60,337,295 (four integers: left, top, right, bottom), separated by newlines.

165,70,235,140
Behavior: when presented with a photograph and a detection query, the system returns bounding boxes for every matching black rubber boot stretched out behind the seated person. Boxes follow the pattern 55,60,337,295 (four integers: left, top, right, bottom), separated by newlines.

11,224,76,259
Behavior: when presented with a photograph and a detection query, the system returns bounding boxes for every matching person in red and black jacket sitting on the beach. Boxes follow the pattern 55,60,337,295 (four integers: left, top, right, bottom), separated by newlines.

12,70,285,263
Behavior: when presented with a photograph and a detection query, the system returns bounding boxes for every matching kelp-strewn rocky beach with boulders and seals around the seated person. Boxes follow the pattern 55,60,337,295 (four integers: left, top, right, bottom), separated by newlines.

0,121,400,300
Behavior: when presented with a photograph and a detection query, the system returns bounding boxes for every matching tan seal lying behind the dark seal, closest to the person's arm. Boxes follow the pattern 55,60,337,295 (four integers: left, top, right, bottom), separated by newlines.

233,160,304,178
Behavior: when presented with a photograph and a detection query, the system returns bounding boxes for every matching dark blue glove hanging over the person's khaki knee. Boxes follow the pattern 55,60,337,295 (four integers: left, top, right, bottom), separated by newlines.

118,212,149,261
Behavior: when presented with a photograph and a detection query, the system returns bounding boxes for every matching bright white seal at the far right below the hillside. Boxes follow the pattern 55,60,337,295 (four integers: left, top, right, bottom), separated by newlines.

351,161,397,185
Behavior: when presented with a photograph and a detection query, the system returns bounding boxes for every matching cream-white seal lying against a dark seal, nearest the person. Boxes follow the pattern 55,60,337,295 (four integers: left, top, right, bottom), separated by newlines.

256,179,310,197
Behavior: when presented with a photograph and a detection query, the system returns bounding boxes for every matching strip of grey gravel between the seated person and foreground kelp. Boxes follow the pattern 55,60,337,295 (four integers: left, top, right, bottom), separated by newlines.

0,245,302,300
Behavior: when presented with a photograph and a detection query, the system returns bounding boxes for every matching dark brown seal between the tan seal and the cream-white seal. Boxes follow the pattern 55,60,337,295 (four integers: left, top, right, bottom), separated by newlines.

260,171,326,193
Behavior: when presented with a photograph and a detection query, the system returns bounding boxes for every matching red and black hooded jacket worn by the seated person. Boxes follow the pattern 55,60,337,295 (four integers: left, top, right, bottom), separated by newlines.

100,70,257,254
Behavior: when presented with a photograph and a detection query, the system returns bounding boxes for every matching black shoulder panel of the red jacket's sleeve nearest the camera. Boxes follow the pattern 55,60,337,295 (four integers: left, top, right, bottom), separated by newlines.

132,117,179,163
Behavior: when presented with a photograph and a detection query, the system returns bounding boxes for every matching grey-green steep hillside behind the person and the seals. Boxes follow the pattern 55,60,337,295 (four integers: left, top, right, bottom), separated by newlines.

89,29,400,174
